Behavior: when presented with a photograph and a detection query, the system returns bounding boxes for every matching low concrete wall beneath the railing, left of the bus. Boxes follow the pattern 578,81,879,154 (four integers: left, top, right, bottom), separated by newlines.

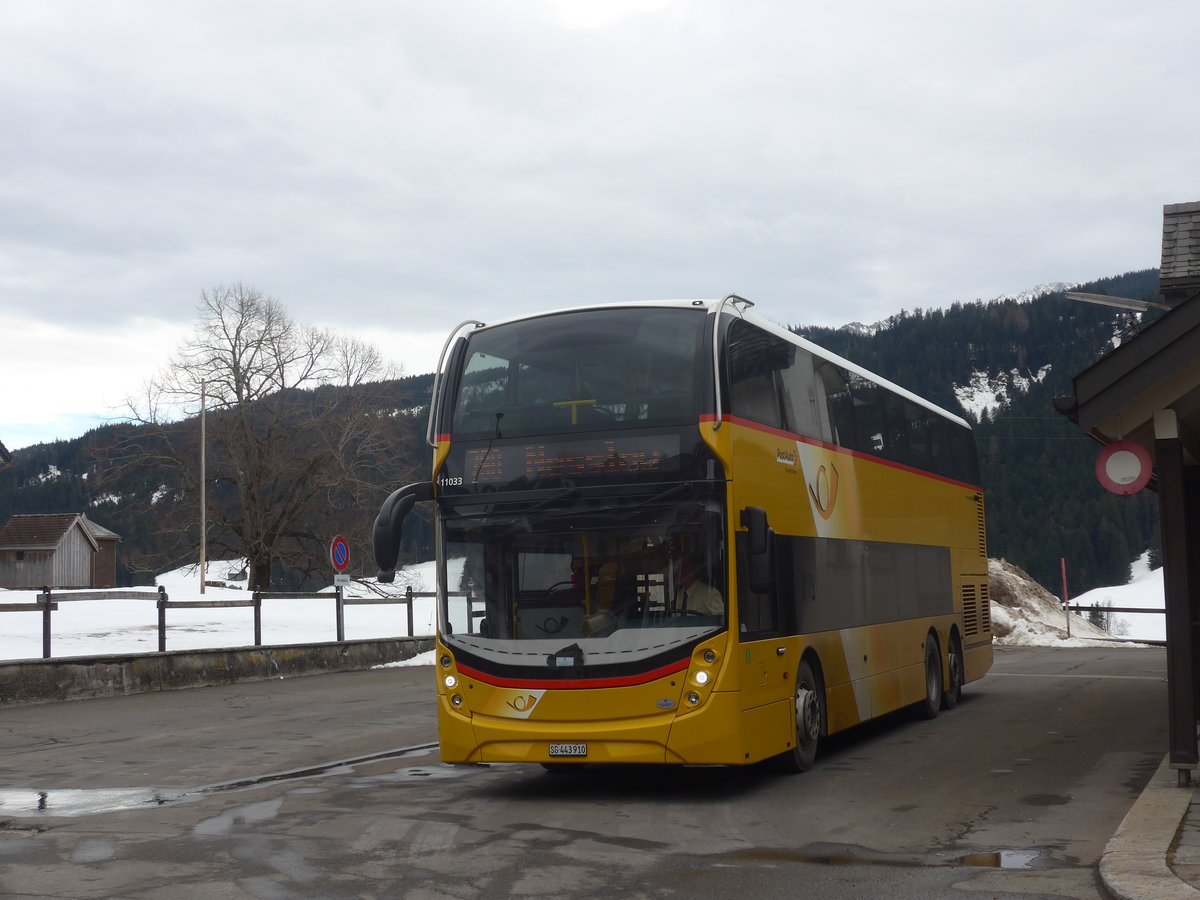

0,637,433,707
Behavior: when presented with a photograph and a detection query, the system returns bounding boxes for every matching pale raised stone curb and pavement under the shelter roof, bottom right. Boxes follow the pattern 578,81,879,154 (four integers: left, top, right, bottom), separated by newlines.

1100,757,1200,900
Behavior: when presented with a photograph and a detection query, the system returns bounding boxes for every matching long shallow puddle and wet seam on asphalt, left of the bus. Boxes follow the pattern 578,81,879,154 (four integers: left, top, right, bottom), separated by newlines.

0,744,437,830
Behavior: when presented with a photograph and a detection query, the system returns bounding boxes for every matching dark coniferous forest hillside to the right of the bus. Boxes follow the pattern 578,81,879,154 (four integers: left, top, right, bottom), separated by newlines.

793,270,1158,596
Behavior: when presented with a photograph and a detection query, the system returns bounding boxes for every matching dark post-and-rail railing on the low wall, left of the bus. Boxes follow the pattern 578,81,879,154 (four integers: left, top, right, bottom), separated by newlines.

0,586,437,659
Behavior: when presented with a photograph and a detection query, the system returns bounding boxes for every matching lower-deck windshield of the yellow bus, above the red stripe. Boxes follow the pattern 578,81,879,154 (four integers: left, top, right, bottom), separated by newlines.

440,502,726,666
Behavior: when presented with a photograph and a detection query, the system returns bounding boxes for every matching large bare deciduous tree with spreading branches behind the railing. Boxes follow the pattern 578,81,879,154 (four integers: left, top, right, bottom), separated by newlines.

108,284,412,590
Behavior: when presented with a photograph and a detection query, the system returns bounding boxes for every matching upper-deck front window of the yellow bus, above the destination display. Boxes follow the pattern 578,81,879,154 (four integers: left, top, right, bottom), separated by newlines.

451,306,707,439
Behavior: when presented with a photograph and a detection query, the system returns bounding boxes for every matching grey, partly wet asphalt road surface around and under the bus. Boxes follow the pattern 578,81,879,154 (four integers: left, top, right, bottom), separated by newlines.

0,648,1166,900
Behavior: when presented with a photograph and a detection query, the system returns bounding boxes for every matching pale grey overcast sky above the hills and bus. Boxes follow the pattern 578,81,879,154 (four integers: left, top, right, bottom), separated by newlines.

0,0,1200,449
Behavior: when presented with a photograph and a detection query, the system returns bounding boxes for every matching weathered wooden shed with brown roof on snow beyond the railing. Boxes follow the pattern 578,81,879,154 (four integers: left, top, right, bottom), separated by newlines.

0,512,120,590
